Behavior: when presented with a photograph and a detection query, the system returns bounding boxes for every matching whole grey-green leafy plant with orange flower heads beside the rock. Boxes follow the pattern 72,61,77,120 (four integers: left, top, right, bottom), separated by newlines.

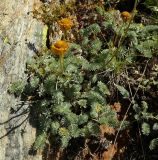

9,0,158,158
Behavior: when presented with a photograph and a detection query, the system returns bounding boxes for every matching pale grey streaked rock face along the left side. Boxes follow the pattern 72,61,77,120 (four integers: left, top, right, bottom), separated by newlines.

0,0,43,160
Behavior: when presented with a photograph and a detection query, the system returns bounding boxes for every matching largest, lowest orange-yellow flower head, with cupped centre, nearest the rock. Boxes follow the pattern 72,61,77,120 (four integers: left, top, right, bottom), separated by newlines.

51,40,69,56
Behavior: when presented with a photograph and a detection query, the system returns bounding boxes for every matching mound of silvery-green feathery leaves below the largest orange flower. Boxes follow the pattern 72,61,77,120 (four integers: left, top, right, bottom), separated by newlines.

10,44,119,149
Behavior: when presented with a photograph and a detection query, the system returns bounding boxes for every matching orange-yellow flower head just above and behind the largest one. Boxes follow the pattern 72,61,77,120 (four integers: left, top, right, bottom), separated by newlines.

58,18,73,30
